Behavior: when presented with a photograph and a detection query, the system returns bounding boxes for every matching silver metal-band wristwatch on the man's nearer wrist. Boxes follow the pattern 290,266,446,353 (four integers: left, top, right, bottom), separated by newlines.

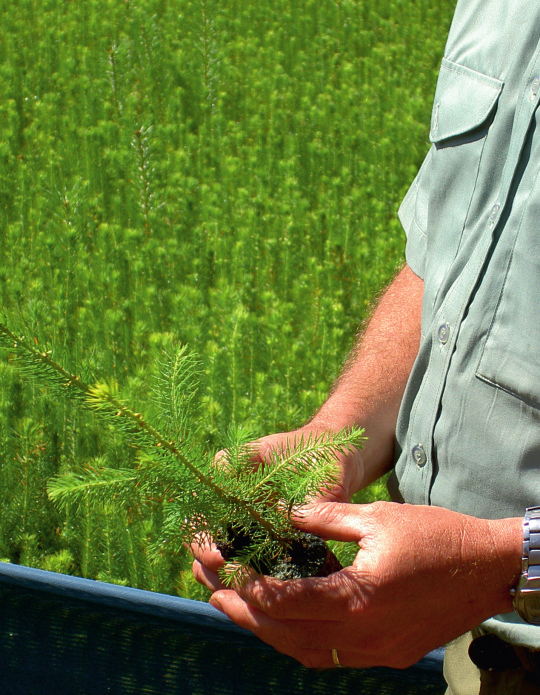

510,507,540,625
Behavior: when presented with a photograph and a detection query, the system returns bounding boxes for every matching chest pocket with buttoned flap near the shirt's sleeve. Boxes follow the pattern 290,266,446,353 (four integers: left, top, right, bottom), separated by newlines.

418,59,503,315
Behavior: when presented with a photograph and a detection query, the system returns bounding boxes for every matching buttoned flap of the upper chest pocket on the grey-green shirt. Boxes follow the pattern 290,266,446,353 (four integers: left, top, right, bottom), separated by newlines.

429,58,504,143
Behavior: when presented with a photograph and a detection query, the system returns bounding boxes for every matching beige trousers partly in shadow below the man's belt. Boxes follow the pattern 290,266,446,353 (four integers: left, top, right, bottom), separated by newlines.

444,632,540,695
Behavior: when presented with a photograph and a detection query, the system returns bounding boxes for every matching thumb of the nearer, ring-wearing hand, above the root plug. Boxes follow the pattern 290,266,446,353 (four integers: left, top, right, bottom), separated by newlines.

293,502,364,543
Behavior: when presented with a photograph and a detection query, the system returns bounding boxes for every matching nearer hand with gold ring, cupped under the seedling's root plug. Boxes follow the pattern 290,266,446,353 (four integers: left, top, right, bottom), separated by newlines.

194,502,522,668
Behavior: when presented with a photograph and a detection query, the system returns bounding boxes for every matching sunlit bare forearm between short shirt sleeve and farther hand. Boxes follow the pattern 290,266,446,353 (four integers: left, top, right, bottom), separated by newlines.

310,266,423,489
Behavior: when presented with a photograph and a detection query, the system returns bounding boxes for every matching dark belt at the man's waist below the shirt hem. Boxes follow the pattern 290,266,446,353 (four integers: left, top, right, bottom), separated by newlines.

469,633,540,675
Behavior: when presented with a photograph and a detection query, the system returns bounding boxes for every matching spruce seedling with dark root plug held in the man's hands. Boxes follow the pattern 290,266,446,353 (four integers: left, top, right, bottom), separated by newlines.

0,323,363,584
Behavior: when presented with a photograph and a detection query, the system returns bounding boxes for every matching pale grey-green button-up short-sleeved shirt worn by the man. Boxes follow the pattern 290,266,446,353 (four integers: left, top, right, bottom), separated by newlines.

390,0,540,647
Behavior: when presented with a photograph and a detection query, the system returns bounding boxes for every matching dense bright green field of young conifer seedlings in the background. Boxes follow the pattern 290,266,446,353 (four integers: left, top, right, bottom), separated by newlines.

0,0,455,597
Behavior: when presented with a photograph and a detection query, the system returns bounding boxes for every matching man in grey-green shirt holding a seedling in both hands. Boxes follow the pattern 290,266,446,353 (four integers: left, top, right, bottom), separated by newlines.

194,0,540,695
